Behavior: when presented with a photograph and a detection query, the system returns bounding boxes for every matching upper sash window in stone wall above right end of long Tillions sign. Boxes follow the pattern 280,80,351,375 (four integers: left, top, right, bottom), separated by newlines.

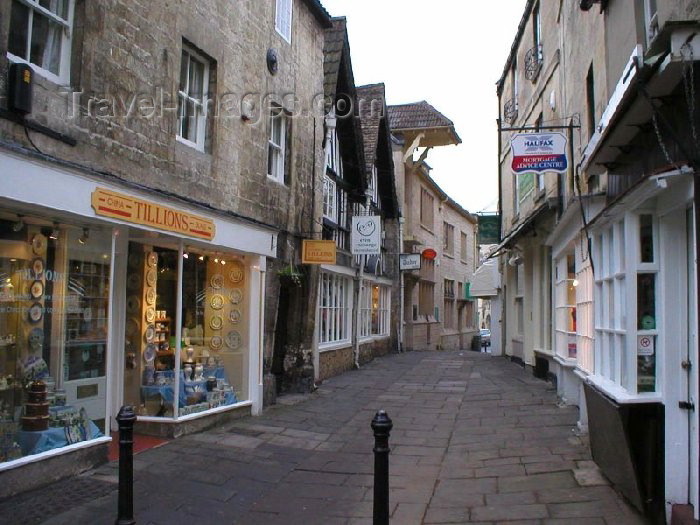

177,44,210,151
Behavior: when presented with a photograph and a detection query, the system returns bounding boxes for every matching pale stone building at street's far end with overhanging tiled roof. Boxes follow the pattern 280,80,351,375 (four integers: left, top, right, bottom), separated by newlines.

389,101,478,350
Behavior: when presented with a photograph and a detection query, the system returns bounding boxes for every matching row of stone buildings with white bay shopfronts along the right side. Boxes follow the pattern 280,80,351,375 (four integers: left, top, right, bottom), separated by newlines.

498,0,700,523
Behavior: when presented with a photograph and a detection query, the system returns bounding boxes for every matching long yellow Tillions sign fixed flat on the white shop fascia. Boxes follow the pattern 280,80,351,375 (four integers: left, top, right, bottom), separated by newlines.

92,188,216,241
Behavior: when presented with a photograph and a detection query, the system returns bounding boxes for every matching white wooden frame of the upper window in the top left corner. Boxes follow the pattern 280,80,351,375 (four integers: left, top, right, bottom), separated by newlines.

7,0,75,86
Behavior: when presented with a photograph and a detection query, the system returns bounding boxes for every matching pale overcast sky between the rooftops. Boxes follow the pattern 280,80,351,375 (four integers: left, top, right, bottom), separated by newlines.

322,0,525,212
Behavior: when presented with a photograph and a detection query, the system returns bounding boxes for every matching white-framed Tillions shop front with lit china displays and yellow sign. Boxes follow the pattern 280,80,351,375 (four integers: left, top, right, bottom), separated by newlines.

0,148,276,497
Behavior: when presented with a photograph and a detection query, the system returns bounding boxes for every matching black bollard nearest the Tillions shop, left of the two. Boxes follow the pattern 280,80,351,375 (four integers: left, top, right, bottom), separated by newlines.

116,406,136,525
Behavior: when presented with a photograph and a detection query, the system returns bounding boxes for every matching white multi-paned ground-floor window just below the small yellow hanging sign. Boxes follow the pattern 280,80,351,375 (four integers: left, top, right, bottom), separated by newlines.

319,273,352,344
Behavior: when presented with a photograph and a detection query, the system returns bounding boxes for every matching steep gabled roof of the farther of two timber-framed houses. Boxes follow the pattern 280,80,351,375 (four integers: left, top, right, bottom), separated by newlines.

357,84,400,218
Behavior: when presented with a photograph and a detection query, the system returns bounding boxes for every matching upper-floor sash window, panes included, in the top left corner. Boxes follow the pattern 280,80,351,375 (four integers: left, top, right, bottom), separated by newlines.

7,0,74,84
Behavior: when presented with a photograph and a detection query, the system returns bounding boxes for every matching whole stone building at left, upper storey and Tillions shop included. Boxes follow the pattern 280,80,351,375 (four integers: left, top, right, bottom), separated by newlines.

0,0,331,496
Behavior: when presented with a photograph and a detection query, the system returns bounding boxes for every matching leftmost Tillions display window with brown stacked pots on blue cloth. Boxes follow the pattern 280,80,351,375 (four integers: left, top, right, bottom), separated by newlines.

0,217,112,462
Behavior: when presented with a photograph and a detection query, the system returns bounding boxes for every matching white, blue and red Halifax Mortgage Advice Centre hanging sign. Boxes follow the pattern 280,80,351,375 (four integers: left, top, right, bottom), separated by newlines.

510,132,569,174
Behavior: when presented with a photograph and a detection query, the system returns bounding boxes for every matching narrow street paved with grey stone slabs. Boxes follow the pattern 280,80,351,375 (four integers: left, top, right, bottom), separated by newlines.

0,351,643,525
